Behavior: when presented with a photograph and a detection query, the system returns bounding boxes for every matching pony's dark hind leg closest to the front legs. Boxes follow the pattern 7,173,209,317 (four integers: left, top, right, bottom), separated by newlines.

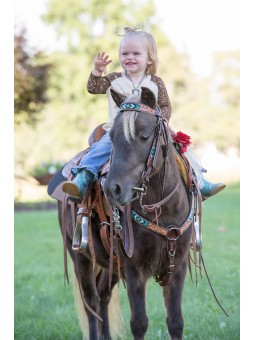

97,269,118,340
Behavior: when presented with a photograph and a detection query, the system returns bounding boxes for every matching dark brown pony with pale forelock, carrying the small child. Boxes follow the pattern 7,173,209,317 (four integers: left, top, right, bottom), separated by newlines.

58,88,196,340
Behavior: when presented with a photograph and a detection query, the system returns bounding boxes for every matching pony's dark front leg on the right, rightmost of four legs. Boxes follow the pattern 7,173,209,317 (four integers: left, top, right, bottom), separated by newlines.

164,262,187,340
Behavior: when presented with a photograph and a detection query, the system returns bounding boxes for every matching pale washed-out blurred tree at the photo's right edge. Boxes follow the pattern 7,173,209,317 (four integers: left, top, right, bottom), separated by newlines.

170,51,240,151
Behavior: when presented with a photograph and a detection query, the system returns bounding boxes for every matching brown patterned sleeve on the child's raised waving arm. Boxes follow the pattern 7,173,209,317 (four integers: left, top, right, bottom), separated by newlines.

87,72,121,94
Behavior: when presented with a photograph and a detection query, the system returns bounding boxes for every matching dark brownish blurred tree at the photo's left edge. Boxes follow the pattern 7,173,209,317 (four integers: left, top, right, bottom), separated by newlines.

14,28,50,125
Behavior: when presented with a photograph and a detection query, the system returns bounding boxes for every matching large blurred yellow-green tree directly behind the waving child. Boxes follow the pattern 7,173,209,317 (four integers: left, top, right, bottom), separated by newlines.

37,0,189,157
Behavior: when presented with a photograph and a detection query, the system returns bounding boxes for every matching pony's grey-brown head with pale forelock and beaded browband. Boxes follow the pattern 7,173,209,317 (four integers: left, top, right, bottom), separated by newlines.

104,88,167,206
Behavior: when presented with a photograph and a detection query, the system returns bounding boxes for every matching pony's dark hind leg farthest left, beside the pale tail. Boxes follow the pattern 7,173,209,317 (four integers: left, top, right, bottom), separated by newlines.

74,254,100,340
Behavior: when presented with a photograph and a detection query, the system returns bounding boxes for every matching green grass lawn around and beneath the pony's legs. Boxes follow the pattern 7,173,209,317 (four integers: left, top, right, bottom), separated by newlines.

14,184,240,340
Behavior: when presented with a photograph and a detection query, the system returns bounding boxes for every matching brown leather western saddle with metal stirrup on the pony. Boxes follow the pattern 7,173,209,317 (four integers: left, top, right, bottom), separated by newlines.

47,124,124,280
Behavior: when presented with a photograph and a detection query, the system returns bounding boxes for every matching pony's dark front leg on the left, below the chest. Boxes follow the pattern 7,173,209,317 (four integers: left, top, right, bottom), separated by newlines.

125,267,148,340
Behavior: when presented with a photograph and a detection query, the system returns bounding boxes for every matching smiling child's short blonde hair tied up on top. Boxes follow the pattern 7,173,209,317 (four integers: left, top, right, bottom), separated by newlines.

120,26,158,75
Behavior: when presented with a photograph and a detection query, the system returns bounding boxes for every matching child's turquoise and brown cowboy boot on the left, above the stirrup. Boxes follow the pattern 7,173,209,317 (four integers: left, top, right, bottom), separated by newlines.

62,169,94,203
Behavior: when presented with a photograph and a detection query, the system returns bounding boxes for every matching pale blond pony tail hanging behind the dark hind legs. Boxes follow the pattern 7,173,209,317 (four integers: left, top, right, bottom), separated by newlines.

73,269,125,339
